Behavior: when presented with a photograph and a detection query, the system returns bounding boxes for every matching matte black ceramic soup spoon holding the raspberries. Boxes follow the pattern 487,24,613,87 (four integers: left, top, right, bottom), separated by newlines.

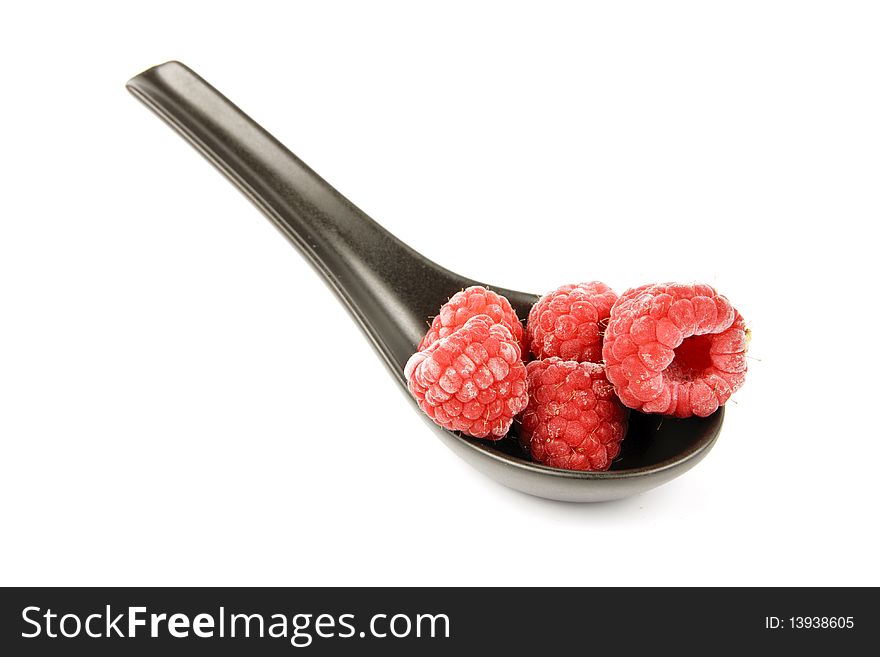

126,62,724,502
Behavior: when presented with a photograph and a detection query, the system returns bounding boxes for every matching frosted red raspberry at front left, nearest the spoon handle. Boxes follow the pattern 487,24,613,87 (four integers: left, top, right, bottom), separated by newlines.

404,315,528,440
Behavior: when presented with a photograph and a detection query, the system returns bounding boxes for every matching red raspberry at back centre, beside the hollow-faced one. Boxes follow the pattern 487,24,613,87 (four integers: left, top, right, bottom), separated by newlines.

527,281,617,363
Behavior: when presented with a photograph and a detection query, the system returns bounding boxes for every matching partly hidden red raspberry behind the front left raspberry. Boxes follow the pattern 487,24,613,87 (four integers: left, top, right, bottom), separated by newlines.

419,285,523,351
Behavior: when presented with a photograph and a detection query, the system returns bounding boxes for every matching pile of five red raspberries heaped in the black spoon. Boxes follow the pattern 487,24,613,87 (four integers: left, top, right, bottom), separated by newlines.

404,281,749,470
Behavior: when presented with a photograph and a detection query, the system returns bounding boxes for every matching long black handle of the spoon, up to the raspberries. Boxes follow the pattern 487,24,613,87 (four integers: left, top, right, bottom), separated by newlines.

126,62,470,379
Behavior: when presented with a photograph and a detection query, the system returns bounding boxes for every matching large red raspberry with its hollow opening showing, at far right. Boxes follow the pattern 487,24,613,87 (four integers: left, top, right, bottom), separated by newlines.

602,283,748,417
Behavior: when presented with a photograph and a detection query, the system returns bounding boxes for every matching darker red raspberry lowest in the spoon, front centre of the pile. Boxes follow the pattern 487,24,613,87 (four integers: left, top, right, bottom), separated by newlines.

522,358,629,470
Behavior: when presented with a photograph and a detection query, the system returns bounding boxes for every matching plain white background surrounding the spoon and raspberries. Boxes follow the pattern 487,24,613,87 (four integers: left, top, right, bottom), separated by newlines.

0,0,880,585
